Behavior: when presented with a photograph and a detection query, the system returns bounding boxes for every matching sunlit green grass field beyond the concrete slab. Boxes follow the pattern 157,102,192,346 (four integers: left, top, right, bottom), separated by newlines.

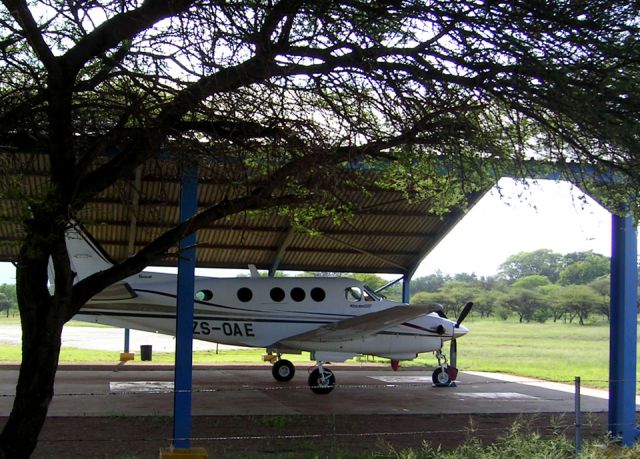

0,317,640,388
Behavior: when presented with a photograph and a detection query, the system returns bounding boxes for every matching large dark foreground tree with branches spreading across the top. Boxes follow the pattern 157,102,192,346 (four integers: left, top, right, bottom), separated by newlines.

0,0,640,458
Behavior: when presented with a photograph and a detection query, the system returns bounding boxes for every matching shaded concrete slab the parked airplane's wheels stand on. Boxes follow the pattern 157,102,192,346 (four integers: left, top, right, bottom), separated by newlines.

0,362,624,416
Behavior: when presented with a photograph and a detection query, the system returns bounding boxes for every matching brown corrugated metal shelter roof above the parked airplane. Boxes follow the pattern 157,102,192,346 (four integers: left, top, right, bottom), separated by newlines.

0,153,484,274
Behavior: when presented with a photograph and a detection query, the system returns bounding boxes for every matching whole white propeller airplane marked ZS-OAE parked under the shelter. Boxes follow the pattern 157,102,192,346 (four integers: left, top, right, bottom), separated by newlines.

61,221,472,394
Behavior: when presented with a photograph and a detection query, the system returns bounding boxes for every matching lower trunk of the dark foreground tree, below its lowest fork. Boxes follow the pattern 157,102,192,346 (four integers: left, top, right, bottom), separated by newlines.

0,321,62,459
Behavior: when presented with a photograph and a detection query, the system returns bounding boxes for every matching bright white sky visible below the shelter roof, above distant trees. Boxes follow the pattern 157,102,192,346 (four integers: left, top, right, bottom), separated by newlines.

0,179,624,284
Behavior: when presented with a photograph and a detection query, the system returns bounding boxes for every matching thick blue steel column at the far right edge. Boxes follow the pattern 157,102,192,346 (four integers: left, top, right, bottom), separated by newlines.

609,215,638,446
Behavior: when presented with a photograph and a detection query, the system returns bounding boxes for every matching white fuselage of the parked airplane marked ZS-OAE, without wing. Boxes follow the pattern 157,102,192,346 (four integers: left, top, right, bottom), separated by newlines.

76,272,467,361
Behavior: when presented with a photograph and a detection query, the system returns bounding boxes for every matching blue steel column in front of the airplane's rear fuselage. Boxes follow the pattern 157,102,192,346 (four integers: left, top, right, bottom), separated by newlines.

173,165,198,449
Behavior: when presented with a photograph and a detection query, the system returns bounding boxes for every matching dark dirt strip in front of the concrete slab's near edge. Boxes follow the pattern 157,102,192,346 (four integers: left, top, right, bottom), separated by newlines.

21,413,607,459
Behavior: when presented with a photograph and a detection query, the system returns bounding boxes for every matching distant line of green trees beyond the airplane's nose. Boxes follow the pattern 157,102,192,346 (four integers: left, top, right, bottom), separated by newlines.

411,249,610,325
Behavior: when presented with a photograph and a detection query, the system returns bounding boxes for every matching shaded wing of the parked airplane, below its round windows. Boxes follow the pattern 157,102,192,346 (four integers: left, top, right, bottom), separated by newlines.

280,304,442,347
